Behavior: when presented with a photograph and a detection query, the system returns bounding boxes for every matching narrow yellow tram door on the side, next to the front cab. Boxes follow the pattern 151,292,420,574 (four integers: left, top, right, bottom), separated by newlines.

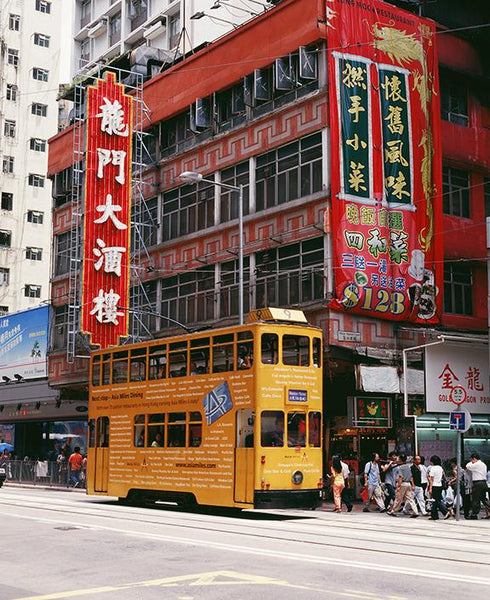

234,408,255,504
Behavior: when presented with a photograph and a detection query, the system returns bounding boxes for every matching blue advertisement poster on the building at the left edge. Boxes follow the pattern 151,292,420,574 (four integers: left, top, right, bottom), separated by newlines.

0,306,49,381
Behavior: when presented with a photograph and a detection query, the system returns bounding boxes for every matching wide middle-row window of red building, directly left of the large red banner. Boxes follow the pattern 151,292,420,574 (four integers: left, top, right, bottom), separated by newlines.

255,133,322,211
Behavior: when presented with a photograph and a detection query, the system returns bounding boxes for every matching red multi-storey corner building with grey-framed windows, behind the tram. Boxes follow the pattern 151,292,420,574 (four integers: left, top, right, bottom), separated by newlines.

41,0,490,461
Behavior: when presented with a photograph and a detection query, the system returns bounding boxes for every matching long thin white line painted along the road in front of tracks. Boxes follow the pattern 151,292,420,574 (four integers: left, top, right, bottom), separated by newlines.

3,513,490,588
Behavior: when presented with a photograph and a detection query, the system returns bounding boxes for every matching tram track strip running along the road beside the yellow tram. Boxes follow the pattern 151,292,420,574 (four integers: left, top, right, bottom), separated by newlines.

0,488,490,567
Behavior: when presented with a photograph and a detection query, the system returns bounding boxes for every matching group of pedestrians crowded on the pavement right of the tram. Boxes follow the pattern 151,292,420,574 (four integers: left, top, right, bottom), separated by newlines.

329,452,490,521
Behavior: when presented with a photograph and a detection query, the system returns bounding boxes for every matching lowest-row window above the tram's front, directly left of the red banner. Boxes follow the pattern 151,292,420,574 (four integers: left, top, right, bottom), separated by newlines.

255,237,324,308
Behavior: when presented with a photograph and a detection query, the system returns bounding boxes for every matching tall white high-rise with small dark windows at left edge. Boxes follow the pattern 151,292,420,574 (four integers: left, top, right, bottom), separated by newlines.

0,0,62,314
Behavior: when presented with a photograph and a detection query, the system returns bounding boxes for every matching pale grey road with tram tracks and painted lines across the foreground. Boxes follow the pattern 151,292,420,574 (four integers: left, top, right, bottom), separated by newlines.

0,485,490,600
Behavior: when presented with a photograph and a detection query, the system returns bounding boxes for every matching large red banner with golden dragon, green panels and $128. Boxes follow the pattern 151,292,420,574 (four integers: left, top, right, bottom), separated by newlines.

327,0,443,323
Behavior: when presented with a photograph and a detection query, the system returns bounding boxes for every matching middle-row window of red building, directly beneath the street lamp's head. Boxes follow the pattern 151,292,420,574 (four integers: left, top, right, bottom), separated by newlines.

162,183,214,240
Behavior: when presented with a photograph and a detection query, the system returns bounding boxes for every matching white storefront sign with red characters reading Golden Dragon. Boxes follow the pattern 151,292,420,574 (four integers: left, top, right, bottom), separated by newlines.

425,343,490,414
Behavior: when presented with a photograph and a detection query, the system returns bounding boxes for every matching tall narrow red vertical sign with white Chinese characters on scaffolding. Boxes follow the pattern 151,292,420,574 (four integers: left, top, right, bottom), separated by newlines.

81,73,133,348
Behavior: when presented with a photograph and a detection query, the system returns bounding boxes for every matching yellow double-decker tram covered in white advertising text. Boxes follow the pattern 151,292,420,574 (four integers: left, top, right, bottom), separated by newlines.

87,308,322,508
